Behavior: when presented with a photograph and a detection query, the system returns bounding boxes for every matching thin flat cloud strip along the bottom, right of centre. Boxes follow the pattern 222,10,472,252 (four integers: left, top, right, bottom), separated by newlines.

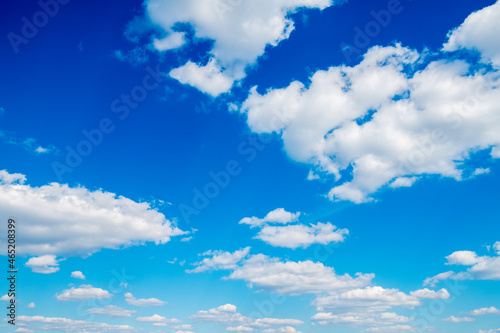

311,312,410,327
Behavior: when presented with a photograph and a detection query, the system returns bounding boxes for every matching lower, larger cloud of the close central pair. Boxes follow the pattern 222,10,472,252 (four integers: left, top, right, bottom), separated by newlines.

255,223,349,249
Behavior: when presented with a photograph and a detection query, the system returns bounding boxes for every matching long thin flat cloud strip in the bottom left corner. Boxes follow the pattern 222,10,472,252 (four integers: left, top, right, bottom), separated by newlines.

17,316,135,333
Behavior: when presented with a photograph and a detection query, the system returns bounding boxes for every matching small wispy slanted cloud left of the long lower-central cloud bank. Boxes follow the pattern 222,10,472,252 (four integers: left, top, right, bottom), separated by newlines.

186,247,250,273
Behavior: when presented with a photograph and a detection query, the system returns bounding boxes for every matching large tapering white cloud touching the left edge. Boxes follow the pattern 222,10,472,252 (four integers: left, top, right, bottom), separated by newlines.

0,173,185,258
